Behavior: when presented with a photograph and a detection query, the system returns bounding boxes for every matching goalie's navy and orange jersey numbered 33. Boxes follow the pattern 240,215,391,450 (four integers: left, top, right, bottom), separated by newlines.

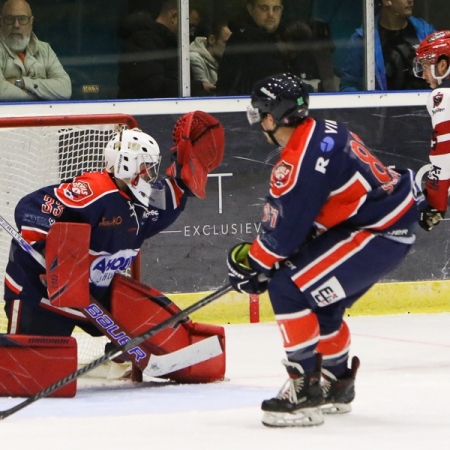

5,171,189,318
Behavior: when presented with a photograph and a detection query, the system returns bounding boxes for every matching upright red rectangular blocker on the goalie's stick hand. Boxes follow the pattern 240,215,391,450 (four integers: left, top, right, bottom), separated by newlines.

45,222,91,308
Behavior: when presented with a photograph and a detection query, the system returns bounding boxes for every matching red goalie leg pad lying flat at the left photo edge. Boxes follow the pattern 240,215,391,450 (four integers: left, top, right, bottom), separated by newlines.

0,334,77,397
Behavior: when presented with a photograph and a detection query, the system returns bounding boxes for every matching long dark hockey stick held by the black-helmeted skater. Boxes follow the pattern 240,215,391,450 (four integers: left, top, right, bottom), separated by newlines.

0,284,233,420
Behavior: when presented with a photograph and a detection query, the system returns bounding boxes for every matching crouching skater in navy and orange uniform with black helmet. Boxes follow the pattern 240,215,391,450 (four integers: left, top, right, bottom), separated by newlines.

228,74,423,427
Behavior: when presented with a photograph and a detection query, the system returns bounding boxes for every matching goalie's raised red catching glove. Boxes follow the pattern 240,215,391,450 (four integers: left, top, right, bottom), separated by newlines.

166,111,225,198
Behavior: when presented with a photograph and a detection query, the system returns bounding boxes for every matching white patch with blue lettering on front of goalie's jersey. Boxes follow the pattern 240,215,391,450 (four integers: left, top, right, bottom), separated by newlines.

90,249,137,287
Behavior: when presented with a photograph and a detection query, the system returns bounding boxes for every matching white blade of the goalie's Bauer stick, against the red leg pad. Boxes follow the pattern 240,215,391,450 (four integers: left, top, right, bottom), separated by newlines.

144,336,222,377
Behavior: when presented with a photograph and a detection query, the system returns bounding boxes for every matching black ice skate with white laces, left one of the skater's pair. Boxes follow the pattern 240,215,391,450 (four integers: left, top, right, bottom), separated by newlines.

261,360,324,427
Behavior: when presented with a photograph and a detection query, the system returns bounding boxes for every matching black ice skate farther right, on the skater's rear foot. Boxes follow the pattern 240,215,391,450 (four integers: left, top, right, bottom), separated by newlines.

320,356,359,414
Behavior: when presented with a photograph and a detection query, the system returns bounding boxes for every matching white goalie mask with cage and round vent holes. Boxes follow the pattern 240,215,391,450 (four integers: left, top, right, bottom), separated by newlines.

105,128,161,206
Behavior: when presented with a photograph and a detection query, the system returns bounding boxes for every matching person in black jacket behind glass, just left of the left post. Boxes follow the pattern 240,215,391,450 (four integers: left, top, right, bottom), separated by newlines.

118,0,179,99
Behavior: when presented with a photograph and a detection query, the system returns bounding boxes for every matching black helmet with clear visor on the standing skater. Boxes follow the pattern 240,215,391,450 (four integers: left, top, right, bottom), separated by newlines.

247,73,309,126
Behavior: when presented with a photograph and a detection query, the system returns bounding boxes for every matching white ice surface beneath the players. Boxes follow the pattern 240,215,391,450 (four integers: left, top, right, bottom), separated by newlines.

0,314,450,450
